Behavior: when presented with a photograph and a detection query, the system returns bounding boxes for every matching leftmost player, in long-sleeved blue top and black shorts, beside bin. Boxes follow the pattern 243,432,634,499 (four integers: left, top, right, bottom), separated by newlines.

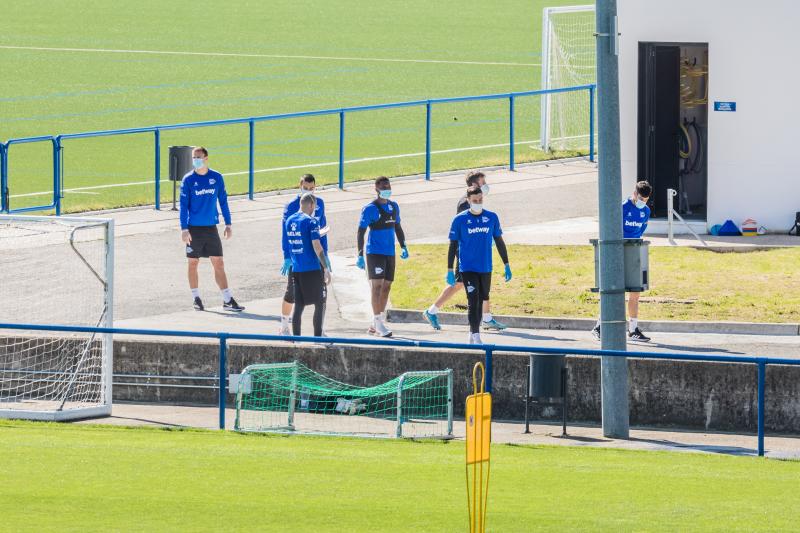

180,146,244,311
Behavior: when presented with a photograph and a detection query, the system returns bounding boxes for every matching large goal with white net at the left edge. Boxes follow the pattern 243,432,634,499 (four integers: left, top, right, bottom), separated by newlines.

0,215,114,420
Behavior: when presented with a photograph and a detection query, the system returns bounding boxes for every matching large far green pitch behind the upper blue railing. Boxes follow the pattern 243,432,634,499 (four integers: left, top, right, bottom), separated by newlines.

0,0,588,211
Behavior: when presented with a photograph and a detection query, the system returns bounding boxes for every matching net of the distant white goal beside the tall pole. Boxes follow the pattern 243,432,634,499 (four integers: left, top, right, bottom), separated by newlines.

540,5,597,151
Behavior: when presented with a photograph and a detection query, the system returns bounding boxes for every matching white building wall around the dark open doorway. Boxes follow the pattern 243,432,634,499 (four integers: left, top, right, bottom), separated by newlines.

620,0,800,231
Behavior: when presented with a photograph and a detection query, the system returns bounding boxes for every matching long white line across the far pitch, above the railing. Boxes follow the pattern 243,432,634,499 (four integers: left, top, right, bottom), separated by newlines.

0,45,542,67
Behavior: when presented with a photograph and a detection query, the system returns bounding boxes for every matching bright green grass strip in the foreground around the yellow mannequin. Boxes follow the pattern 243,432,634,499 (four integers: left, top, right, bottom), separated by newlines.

0,422,800,532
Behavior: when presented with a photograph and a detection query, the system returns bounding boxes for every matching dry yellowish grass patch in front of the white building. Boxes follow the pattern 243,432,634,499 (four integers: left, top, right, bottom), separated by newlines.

392,245,800,323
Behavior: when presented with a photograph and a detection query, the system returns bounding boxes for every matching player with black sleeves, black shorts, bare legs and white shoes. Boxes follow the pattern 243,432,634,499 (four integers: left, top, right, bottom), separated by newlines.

356,176,408,337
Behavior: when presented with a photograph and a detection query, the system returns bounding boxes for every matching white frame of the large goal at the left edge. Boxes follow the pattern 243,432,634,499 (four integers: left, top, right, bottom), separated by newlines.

0,214,114,422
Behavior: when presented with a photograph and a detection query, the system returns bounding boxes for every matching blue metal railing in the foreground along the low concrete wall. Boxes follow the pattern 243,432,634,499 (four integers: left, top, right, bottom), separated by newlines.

0,323,800,456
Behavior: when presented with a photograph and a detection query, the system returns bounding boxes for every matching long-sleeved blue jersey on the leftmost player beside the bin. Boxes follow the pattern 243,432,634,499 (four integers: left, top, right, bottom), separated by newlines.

180,169,231,229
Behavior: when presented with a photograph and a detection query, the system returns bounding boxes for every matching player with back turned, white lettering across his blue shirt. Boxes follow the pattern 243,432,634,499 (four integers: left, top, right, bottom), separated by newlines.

284,193,331,337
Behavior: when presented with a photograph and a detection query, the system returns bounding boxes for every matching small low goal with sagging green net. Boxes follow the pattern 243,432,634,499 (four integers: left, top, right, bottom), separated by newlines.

235,362,453,439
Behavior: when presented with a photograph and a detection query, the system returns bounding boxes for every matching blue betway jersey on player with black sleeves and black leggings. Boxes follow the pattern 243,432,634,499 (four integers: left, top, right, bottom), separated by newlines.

450,210,503,274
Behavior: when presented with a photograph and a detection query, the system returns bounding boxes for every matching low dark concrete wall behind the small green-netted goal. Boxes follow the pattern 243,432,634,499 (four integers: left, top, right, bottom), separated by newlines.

114,341,800,433
